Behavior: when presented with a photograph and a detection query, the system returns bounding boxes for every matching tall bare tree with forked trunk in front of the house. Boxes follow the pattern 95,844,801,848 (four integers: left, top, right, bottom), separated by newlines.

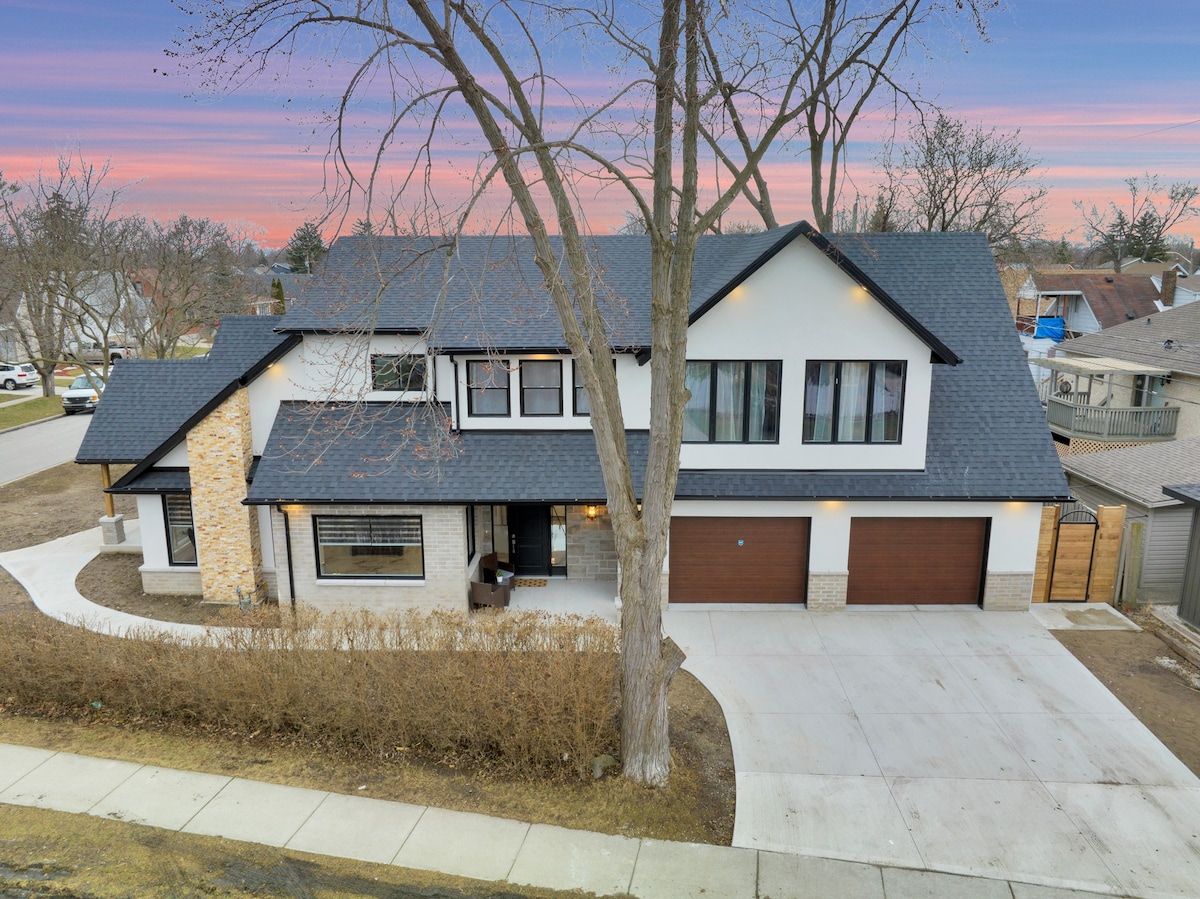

175,0,994,785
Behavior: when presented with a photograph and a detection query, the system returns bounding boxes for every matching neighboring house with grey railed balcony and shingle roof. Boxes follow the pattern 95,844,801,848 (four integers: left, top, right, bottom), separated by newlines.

1038,304,1200,455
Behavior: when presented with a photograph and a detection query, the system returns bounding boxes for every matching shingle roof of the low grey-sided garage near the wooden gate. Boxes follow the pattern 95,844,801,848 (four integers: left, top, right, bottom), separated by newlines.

1062,438,1200,508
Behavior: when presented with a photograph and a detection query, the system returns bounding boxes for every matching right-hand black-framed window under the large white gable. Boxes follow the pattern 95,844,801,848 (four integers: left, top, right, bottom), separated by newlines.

804,361,905,443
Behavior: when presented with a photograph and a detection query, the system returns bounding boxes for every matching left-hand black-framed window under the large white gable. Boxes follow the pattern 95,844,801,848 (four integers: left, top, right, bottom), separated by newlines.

683,361,784,443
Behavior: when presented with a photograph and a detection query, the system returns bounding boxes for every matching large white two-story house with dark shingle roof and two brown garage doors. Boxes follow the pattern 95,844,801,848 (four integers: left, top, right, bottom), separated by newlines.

77,223,1068,609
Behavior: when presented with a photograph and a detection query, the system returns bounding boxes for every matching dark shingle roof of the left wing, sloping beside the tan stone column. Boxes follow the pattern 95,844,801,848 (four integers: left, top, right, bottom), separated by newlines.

76,316,300,478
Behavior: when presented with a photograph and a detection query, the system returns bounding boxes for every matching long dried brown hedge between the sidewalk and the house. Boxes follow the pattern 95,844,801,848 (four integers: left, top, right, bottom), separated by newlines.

0,611,619,775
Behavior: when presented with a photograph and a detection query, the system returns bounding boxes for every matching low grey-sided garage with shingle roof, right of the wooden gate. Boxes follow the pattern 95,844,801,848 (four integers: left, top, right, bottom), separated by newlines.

1062,439,1200,603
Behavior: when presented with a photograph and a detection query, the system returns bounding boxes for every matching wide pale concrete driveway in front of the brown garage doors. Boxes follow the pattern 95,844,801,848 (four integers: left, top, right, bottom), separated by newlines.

665,606,1200,897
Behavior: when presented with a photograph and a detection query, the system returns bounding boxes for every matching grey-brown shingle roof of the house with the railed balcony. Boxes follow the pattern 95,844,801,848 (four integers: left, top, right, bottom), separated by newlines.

1058,302,1200,374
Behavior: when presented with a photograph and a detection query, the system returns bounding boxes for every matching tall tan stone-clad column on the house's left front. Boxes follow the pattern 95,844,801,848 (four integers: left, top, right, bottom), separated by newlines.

187,388,265,603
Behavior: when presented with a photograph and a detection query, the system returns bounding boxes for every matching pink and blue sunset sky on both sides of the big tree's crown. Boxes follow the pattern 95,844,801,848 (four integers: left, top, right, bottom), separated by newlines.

0,0,1200,246
